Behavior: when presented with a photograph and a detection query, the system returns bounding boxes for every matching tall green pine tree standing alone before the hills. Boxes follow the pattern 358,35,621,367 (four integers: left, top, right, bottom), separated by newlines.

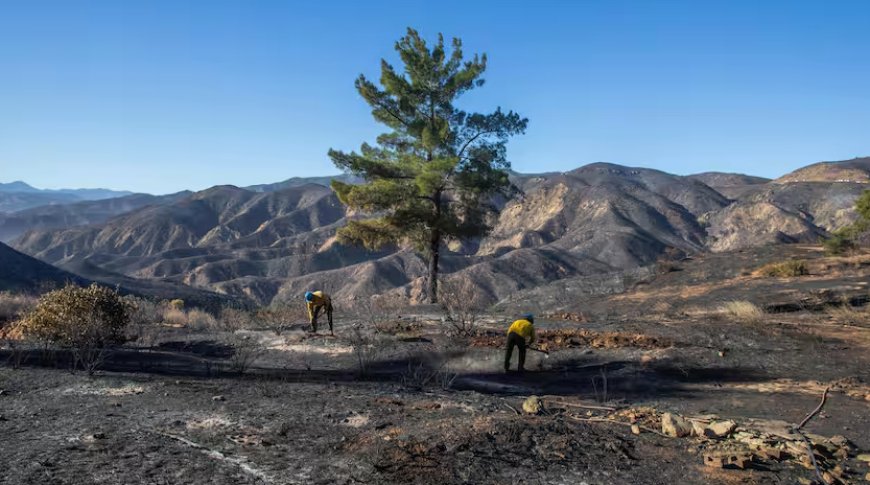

329,28,528,303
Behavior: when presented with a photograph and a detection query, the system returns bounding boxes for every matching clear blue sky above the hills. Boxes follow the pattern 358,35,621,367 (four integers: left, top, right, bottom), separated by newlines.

0,0,870,193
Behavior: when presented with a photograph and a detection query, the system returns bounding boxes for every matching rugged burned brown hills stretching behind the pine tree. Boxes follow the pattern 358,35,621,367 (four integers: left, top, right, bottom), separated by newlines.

0,159,870,303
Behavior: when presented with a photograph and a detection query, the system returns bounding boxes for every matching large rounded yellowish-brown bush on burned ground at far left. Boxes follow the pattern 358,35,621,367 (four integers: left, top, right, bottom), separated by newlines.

20,284,130,374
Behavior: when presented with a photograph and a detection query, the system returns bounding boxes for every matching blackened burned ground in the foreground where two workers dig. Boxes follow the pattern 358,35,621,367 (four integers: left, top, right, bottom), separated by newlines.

0,246,870,484
